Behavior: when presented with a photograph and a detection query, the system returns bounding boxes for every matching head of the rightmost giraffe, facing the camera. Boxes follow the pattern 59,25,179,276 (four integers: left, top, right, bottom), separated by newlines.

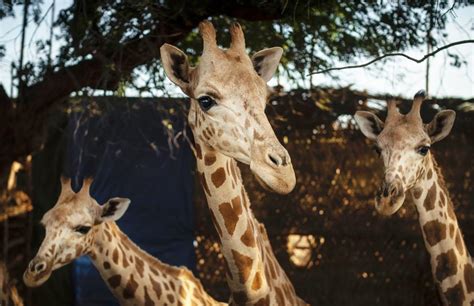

355,91,456,215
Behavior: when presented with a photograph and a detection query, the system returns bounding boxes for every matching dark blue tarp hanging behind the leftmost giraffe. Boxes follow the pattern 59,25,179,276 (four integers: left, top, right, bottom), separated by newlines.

65,98,195,306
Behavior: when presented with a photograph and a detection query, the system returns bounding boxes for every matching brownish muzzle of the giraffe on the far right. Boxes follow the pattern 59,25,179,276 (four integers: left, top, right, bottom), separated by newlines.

375,179,405,216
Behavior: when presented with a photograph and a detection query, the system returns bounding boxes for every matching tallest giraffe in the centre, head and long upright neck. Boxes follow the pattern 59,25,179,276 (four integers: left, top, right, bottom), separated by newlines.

160,21,306,305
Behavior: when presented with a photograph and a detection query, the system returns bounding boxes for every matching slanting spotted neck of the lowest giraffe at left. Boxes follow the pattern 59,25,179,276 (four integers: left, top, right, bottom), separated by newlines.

89,222,219,306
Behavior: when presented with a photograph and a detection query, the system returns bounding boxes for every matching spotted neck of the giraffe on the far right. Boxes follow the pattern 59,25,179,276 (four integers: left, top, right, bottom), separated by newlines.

411,155,474,305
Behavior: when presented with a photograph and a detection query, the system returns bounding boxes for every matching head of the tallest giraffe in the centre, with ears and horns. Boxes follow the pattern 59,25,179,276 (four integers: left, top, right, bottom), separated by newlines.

160,21,296,194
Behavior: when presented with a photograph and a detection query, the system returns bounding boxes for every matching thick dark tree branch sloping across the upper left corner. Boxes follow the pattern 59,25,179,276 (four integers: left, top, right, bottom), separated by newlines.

0,0,290,172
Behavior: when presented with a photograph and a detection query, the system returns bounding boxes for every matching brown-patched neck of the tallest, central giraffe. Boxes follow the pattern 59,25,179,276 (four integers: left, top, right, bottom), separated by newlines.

195,142,304,305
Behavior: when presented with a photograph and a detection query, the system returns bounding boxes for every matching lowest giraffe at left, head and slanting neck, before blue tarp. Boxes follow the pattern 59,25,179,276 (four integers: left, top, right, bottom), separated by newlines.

23,180,225,306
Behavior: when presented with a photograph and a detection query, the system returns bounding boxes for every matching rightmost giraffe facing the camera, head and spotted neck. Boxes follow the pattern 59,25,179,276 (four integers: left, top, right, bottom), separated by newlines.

355,91,474,305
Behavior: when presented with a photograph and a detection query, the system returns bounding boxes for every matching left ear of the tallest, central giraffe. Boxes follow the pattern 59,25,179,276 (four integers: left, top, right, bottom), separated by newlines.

160,44,191,93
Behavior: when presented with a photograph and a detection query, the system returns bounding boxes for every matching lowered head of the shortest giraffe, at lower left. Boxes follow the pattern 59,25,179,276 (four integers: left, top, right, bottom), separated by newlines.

23,178,130,287
